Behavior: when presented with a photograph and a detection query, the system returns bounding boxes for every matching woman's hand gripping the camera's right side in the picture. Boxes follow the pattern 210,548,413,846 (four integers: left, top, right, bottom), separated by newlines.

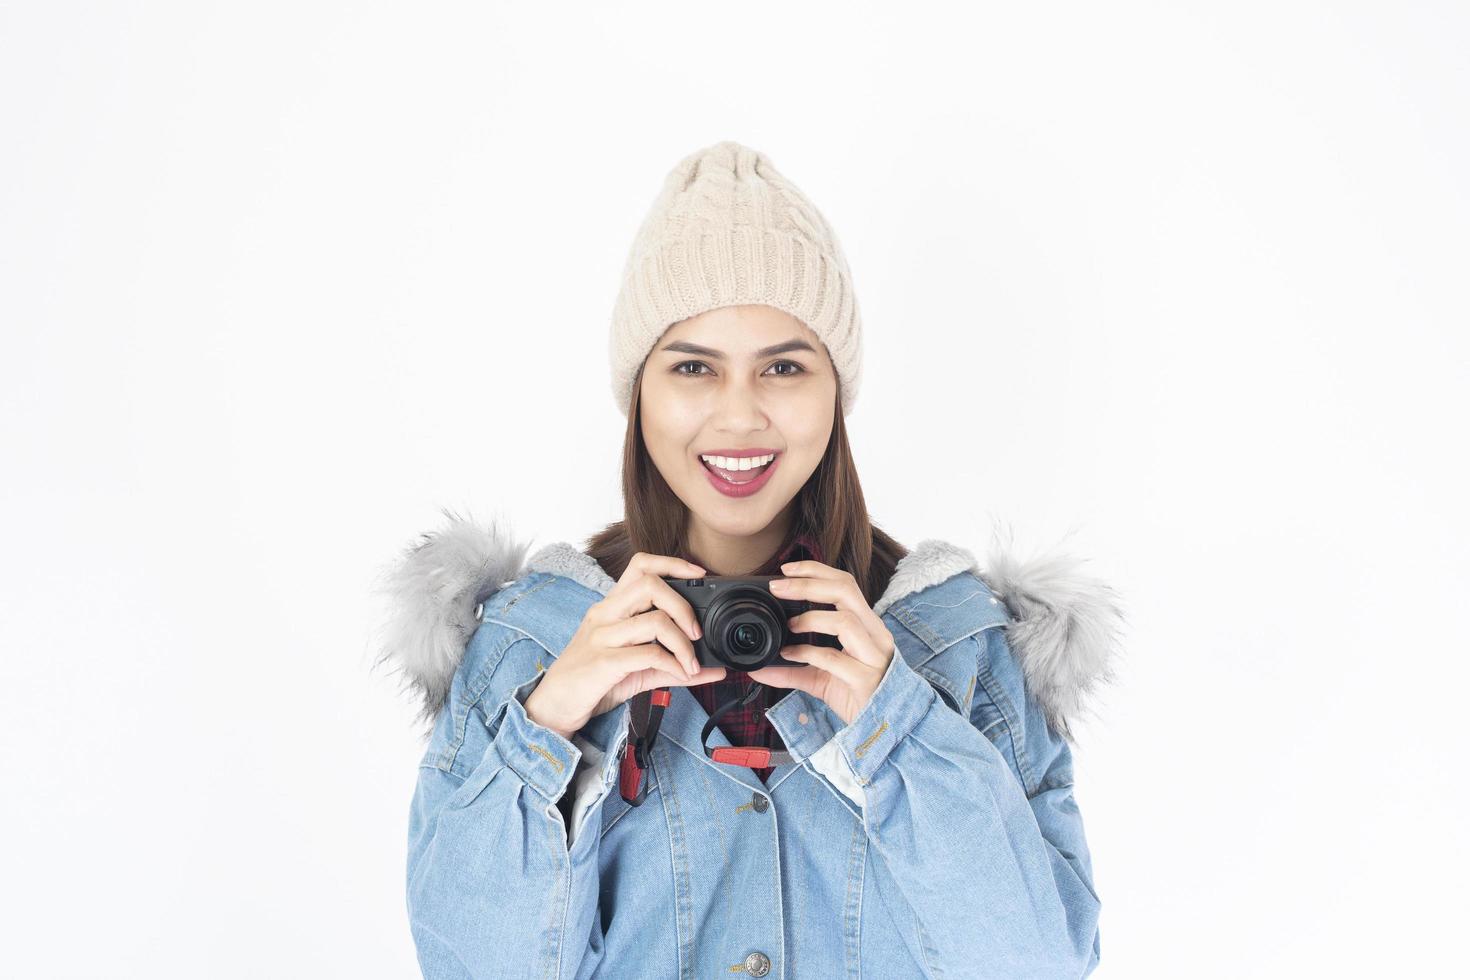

750,561,897,724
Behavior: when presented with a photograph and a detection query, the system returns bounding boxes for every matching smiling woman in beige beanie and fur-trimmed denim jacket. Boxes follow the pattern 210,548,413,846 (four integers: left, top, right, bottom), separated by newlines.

385,141,1119,979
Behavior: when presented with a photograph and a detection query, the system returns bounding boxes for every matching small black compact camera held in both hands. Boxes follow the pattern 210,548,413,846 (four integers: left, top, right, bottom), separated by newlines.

662,574,842,673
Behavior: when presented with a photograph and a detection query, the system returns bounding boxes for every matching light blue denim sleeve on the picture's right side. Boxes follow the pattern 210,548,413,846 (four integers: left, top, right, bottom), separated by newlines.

814,629,1101,980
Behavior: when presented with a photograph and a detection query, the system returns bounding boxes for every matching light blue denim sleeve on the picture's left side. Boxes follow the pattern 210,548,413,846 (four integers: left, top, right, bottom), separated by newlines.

407,623,629,980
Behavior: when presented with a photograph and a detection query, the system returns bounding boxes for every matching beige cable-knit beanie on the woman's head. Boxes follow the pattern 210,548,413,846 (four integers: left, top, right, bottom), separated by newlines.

609,140,863,416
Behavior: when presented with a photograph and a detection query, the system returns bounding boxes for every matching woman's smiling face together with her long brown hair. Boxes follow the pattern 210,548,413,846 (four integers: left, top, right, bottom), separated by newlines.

587,301,906,602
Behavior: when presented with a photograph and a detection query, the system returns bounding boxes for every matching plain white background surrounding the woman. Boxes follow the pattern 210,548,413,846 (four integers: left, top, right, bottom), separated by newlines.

0,1,1470,977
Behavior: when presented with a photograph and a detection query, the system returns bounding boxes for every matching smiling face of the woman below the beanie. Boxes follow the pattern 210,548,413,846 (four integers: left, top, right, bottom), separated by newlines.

638,306,836,570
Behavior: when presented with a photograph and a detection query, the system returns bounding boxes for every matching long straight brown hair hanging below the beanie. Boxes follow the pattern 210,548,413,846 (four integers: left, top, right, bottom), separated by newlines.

585,361,908,605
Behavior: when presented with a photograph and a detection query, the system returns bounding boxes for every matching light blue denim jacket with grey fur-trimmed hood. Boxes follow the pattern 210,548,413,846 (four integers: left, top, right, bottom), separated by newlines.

373,516,1122,980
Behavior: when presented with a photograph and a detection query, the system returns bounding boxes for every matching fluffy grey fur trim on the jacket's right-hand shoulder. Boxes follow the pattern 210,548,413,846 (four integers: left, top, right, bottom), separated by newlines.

980,528,1126,742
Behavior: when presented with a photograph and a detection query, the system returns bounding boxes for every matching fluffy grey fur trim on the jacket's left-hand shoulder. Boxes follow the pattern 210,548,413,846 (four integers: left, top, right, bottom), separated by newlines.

373,510,528,723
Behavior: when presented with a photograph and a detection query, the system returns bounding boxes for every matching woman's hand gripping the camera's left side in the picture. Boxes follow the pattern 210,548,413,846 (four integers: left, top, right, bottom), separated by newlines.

525,551,725,739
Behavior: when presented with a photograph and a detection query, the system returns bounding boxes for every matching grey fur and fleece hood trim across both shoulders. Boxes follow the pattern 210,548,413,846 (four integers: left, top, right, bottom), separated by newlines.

375,511,1125,739
